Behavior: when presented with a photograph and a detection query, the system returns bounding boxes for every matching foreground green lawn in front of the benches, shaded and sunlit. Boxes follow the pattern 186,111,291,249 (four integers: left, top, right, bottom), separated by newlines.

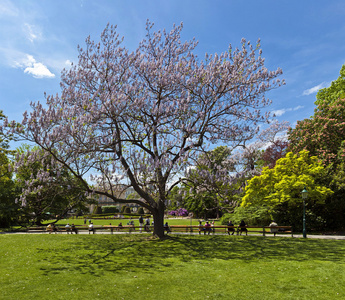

0,234,345,300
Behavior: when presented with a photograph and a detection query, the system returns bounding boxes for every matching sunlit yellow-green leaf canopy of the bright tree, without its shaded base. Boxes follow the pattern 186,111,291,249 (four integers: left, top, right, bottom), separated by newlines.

241,150,333,208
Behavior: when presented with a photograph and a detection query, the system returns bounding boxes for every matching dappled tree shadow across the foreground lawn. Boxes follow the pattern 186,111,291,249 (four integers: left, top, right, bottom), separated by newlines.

38,235,345,275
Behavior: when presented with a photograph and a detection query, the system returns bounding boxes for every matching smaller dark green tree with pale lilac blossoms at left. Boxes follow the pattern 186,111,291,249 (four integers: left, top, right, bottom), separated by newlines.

15,145,88,225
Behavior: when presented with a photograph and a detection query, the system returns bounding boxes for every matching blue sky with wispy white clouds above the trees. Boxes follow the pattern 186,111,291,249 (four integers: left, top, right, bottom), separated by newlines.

0,0,345,134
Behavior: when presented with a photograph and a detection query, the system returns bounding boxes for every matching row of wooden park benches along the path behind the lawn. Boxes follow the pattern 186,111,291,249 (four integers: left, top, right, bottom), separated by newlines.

27,225,293,237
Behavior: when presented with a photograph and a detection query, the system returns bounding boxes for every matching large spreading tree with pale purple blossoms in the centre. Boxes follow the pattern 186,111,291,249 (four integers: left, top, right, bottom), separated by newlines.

6,22,282,238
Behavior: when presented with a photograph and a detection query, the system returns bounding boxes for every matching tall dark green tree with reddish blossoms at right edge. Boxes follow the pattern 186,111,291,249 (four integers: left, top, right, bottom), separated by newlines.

289,90,345,229
